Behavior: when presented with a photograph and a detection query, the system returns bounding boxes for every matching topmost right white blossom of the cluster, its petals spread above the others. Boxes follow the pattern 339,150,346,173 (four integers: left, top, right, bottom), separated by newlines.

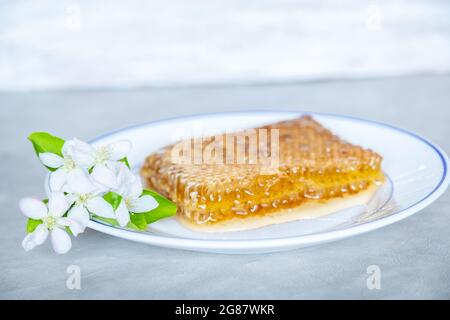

68,139,132,189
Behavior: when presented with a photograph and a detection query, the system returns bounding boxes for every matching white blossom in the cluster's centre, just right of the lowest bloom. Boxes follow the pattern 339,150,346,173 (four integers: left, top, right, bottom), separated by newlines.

64,169,116,234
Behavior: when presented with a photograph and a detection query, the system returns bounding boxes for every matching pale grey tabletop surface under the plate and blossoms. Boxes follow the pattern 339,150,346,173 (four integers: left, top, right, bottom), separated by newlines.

0,77,450,299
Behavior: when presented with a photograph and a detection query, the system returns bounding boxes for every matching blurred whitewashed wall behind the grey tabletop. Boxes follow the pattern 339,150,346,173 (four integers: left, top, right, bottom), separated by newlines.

0,0,450,91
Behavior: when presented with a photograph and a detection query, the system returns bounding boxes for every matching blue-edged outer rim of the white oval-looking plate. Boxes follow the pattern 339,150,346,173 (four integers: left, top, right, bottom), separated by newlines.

81,110,450,250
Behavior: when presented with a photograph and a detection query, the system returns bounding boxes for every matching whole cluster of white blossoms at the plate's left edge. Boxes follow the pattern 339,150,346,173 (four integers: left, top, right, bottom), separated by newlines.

20,139,158,254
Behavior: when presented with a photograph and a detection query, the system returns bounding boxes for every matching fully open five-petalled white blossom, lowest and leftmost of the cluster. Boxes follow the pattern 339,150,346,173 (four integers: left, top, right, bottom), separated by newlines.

20,192,79,254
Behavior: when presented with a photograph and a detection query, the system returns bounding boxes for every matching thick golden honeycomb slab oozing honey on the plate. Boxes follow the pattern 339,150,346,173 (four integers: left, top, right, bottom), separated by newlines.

141,116,385,231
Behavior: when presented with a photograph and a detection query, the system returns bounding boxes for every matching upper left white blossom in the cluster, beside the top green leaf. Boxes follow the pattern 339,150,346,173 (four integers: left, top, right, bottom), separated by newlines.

39,140,79,191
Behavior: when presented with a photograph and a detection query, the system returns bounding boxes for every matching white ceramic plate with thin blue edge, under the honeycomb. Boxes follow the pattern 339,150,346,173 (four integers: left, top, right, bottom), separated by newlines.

83,112,449,254
